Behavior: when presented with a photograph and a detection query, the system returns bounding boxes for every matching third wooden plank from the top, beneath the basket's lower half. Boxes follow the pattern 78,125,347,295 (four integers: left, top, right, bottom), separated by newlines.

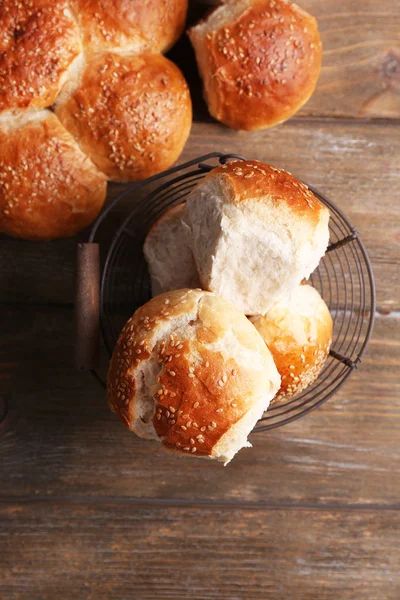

0,307,400,505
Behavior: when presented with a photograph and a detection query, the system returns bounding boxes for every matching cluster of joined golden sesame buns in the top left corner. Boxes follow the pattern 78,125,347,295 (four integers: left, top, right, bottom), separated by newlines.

0,0,191,239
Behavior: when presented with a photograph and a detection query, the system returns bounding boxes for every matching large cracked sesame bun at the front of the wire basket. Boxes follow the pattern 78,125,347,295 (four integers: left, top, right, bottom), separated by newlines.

108,289,280,463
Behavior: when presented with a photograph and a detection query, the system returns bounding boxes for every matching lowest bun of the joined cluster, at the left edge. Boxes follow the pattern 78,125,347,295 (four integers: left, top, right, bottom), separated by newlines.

0,110,107,240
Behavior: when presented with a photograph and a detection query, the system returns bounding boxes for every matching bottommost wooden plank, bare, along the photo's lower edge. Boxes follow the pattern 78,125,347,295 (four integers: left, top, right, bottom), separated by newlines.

0,500,400,600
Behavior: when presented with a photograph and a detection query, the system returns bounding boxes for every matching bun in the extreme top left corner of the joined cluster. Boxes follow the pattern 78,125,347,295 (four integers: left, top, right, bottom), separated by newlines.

0,0,82,113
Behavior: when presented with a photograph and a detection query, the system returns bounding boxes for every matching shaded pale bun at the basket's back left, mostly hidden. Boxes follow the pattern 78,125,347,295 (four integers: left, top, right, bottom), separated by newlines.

143,204,201,296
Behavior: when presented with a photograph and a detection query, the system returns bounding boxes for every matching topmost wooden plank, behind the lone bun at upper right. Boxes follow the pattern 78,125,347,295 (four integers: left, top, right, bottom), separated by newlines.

170,0,400,122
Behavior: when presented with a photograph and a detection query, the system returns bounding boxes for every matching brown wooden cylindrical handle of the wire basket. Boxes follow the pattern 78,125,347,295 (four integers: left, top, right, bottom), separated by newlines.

75,243,100,370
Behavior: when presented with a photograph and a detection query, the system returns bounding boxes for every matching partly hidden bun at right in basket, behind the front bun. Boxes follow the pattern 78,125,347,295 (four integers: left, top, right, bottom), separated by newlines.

250,285,332,403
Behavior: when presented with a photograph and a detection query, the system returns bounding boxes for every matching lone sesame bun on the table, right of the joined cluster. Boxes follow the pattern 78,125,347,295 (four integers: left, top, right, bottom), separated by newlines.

189,0,322,130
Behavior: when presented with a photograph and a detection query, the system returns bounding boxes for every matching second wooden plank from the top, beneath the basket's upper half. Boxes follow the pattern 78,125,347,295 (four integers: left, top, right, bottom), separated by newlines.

0,122,400,312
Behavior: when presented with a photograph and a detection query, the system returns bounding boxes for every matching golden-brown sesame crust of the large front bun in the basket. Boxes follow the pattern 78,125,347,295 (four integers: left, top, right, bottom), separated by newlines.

108,290,276,456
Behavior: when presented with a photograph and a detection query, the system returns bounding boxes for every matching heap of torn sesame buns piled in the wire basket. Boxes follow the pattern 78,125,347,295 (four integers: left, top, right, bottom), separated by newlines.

108,161,332,463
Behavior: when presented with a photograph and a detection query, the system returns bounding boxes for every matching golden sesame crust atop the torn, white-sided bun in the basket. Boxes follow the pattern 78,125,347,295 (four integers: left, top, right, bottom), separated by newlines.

211,160,328,224
